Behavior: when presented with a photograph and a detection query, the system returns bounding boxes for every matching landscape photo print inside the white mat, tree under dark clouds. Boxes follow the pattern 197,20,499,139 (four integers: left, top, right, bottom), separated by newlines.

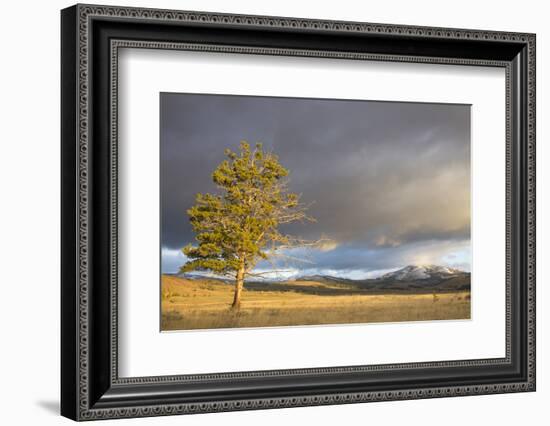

160,93,471,331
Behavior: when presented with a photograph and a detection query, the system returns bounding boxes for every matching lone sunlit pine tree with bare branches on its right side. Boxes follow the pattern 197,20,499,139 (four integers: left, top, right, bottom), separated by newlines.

181,141,315,308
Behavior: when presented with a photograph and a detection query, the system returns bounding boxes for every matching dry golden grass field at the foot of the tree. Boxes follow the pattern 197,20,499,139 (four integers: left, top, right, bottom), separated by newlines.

161,276,470,331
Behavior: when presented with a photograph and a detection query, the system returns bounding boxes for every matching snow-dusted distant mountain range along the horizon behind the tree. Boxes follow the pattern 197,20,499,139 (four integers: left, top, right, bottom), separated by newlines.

176,265,470,291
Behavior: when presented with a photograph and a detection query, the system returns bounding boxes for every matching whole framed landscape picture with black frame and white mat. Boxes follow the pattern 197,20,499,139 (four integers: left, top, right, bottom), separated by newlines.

61,5,535,420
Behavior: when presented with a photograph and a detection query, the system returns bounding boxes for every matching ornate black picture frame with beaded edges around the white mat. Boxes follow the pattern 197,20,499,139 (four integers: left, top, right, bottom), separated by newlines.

61,5,535,420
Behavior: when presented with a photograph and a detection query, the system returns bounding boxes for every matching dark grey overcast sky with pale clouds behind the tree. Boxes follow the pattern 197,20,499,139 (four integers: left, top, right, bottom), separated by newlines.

160,93,471,278
